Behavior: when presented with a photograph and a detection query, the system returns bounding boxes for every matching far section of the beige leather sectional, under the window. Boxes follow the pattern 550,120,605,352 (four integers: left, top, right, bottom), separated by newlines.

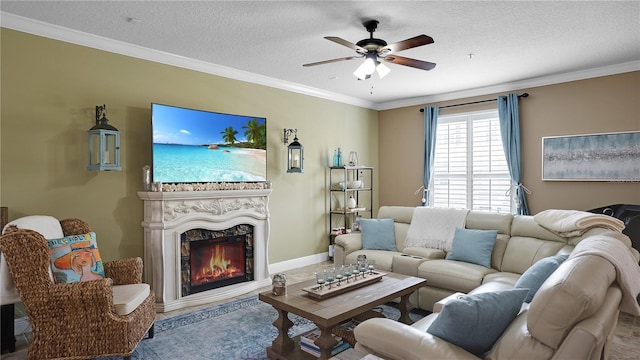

334,206,608,311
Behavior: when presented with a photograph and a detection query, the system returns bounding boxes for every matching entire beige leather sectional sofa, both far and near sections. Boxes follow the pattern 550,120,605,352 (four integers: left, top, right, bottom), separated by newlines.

334,206,640,360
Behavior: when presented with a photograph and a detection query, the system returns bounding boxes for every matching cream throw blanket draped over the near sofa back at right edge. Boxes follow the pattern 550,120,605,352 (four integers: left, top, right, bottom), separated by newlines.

569,234,640,316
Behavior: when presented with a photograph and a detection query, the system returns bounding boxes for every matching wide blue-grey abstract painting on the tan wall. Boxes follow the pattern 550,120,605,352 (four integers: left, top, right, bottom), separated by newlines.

542,131,640,181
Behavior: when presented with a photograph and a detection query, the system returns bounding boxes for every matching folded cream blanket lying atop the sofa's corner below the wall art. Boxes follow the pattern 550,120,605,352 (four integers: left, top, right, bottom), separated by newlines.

533,209,624,237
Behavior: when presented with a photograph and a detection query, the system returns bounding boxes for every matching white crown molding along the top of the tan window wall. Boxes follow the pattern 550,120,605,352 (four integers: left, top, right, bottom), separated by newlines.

375,61,640,111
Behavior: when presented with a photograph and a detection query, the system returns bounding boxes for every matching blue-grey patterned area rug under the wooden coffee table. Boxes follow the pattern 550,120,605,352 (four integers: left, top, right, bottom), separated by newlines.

107,296,421,360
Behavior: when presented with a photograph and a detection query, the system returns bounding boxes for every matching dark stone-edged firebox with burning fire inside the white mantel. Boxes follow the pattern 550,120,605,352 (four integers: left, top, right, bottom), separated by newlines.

181,225,253,296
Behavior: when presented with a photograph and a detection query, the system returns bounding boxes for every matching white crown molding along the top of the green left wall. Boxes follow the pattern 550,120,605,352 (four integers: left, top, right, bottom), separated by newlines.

0,12,375,109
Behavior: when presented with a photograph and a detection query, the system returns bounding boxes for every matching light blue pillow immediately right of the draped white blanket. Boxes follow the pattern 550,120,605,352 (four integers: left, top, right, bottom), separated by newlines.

447,228,498,268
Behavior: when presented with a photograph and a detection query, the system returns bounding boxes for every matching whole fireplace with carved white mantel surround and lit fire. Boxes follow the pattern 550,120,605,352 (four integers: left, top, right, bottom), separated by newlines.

138,188,271,312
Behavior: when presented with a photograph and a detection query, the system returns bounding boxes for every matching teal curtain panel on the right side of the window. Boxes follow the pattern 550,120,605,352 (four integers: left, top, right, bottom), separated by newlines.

500,93,531,215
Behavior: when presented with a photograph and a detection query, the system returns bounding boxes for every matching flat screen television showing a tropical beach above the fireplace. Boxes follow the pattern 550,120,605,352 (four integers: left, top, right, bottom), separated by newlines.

151,103,267,183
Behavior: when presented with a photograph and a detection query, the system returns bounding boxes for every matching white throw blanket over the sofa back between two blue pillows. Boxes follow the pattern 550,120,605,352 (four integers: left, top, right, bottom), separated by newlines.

404,206,469,252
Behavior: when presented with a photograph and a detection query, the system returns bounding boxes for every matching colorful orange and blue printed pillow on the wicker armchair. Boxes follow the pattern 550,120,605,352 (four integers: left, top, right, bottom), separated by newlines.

47,232,104,284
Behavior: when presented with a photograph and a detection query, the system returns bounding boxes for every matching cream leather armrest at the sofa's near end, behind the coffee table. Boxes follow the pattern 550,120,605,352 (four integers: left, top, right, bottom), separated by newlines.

354,318,478,360
